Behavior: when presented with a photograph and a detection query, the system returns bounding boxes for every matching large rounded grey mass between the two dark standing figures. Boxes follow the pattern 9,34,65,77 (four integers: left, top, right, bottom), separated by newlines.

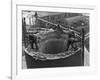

39,32,68,54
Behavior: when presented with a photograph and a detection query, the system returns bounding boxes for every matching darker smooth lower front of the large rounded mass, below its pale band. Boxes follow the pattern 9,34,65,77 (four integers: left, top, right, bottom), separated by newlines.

42,39,67,54
